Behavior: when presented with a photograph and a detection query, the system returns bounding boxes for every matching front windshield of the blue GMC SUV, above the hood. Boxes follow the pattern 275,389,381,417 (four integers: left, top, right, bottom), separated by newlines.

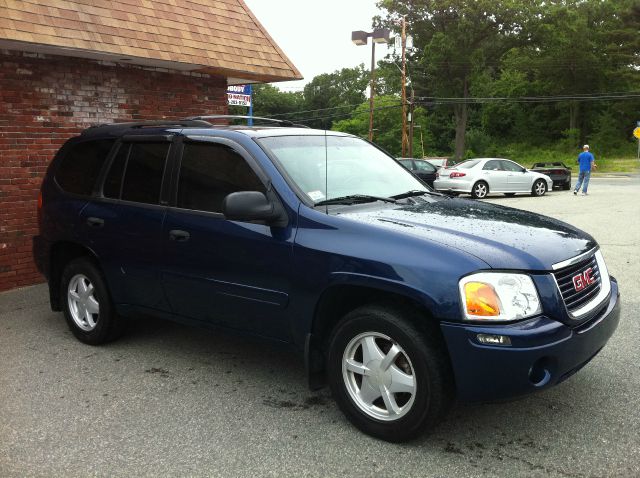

258,136,429,203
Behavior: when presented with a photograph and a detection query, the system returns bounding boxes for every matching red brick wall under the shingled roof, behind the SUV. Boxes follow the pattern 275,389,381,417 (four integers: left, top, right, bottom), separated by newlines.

0,50,227,291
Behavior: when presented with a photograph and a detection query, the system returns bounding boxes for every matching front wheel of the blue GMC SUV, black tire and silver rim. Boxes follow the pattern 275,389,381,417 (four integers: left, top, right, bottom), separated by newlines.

327,305,454,442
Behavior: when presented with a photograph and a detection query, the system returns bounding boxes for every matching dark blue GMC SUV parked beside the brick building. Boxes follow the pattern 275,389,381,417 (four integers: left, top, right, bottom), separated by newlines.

33,117,619,441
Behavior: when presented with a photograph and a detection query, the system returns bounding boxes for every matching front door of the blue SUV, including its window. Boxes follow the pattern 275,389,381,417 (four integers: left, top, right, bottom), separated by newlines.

162,138,294,339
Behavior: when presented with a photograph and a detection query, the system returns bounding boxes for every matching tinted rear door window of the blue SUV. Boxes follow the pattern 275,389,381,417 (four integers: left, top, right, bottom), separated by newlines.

103,143,170,204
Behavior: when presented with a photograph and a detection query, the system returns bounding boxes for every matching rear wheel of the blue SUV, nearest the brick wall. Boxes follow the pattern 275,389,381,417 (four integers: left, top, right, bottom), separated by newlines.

60,257,126,345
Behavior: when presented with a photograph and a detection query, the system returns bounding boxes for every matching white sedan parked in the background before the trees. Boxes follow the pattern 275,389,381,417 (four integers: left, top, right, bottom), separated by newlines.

433,158,553,199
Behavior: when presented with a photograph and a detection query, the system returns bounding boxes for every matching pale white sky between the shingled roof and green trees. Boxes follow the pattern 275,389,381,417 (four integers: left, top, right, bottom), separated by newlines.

245,0,387,91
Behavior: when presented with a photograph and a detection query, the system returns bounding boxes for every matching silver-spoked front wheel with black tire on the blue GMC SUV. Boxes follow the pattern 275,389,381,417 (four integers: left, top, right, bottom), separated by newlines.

327,306,452,442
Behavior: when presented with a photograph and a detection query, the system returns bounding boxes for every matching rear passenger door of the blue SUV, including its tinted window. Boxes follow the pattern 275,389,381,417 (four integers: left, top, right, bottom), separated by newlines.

81,136,172,311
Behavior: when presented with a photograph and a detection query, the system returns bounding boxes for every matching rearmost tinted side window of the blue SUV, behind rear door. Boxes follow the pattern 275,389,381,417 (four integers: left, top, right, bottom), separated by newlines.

56,139,114,196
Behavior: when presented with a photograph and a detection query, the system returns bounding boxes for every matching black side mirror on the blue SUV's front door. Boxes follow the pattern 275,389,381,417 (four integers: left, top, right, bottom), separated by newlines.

222,191,287,226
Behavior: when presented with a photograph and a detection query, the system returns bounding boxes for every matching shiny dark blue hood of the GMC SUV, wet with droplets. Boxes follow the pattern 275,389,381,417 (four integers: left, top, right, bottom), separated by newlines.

340,198,597,270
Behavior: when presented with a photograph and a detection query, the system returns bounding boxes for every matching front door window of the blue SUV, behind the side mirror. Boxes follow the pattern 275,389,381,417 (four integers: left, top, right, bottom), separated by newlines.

177,143,266,212
